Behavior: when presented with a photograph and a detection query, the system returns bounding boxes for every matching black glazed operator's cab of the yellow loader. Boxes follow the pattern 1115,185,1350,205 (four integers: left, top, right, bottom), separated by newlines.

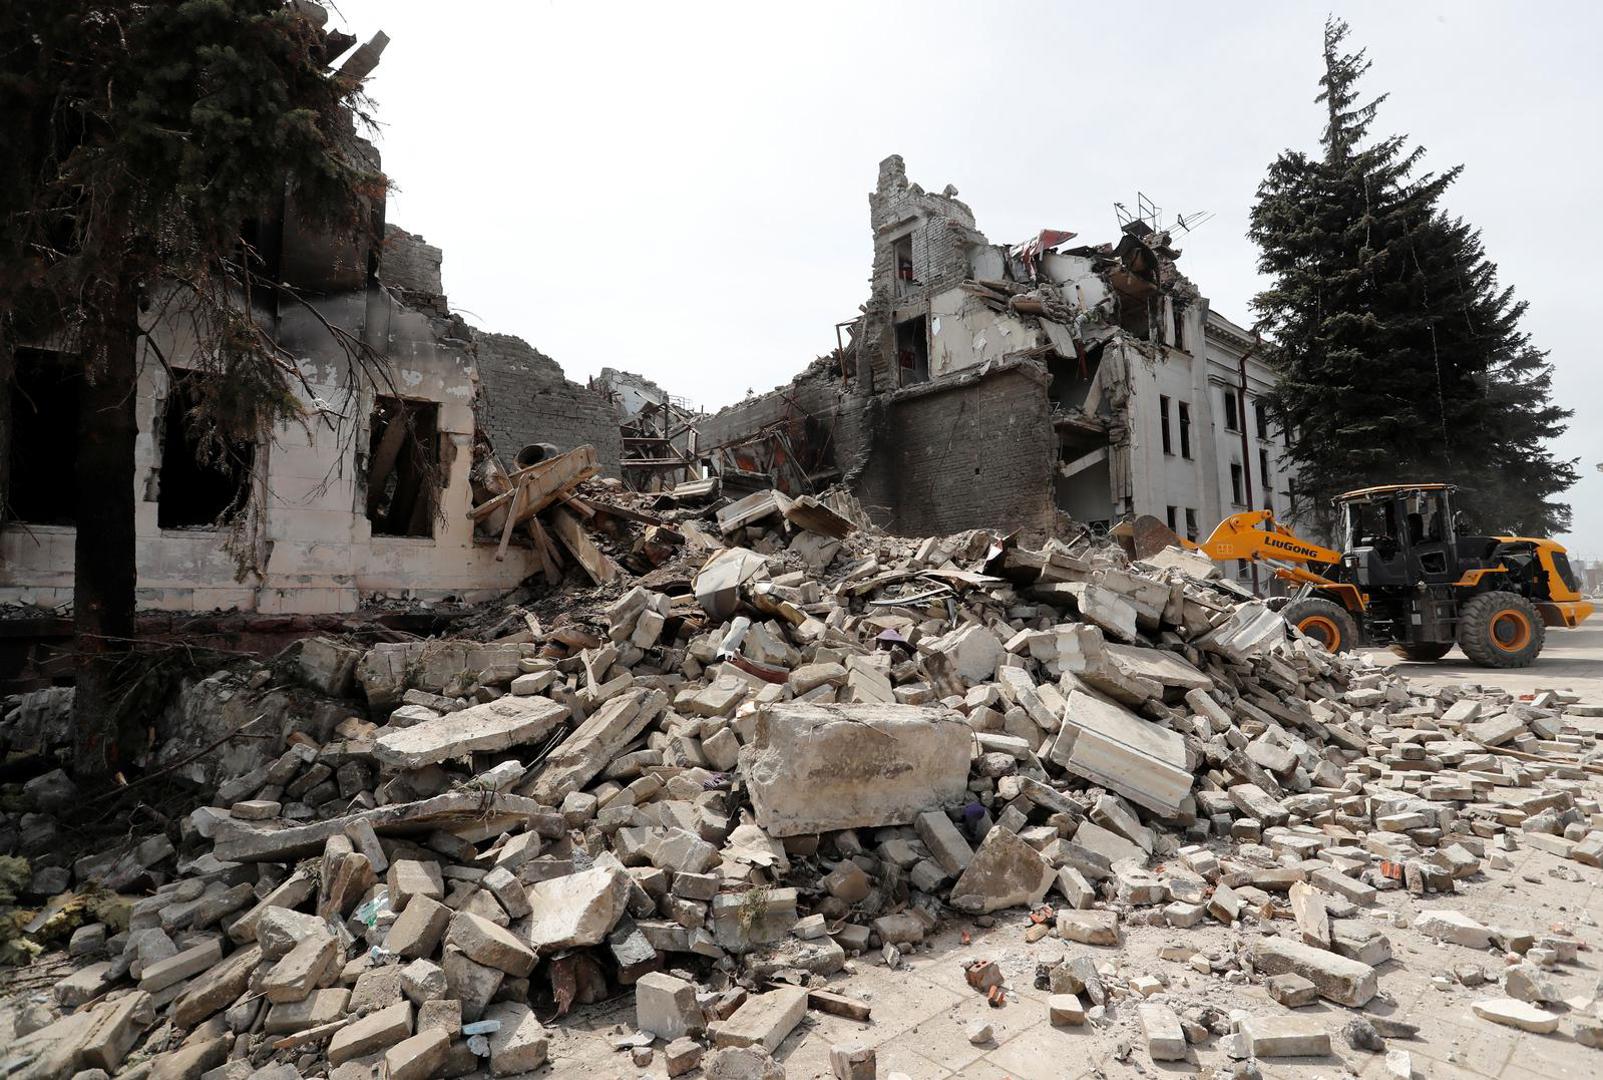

1335,484,1459,590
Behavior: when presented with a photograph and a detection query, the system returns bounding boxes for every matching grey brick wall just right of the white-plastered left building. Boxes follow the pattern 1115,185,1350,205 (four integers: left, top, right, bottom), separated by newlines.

473,332,624,476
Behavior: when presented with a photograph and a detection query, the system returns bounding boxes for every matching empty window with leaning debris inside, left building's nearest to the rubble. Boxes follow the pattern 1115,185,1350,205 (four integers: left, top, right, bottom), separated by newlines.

367,397,444,537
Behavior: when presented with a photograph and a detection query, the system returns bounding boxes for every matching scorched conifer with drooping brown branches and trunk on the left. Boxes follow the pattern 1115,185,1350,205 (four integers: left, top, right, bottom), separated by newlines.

0,0,385,780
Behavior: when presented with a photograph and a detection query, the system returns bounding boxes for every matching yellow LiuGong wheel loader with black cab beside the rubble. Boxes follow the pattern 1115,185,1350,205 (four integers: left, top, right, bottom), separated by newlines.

1133,484,1592,668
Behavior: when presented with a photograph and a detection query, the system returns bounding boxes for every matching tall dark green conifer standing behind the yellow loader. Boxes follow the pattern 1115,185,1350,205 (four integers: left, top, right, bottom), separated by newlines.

1249,19,1577,535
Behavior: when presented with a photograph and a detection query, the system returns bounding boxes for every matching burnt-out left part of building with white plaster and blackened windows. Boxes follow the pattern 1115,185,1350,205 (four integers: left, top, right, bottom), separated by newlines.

0,196,620,614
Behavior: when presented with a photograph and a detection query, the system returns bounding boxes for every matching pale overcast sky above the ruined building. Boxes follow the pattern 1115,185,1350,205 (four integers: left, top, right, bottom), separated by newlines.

337,0,1603,558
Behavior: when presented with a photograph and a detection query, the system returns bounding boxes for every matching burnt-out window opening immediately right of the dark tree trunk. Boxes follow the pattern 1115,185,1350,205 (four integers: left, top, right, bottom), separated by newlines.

155,372,256,529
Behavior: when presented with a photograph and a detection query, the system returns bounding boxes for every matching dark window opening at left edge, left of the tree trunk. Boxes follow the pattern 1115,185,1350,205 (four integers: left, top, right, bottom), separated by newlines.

5,349,82,526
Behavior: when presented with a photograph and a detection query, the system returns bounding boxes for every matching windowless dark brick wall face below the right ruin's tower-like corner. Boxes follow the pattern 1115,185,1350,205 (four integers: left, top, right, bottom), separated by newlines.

859,364,1056,535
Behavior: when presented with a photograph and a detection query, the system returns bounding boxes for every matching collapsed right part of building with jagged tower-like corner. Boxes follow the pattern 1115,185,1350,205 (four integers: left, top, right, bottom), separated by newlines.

699,155,1292,567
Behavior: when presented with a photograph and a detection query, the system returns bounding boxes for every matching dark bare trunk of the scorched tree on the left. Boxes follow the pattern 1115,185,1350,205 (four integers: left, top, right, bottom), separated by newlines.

72,276,138,782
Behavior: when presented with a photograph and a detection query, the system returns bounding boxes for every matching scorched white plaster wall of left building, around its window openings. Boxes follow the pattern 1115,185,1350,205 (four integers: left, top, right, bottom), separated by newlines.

0,290,535,614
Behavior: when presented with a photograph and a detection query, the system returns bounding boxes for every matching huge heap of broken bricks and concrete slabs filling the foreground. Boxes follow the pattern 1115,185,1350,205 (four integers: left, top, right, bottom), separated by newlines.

5,490,1603,1080
